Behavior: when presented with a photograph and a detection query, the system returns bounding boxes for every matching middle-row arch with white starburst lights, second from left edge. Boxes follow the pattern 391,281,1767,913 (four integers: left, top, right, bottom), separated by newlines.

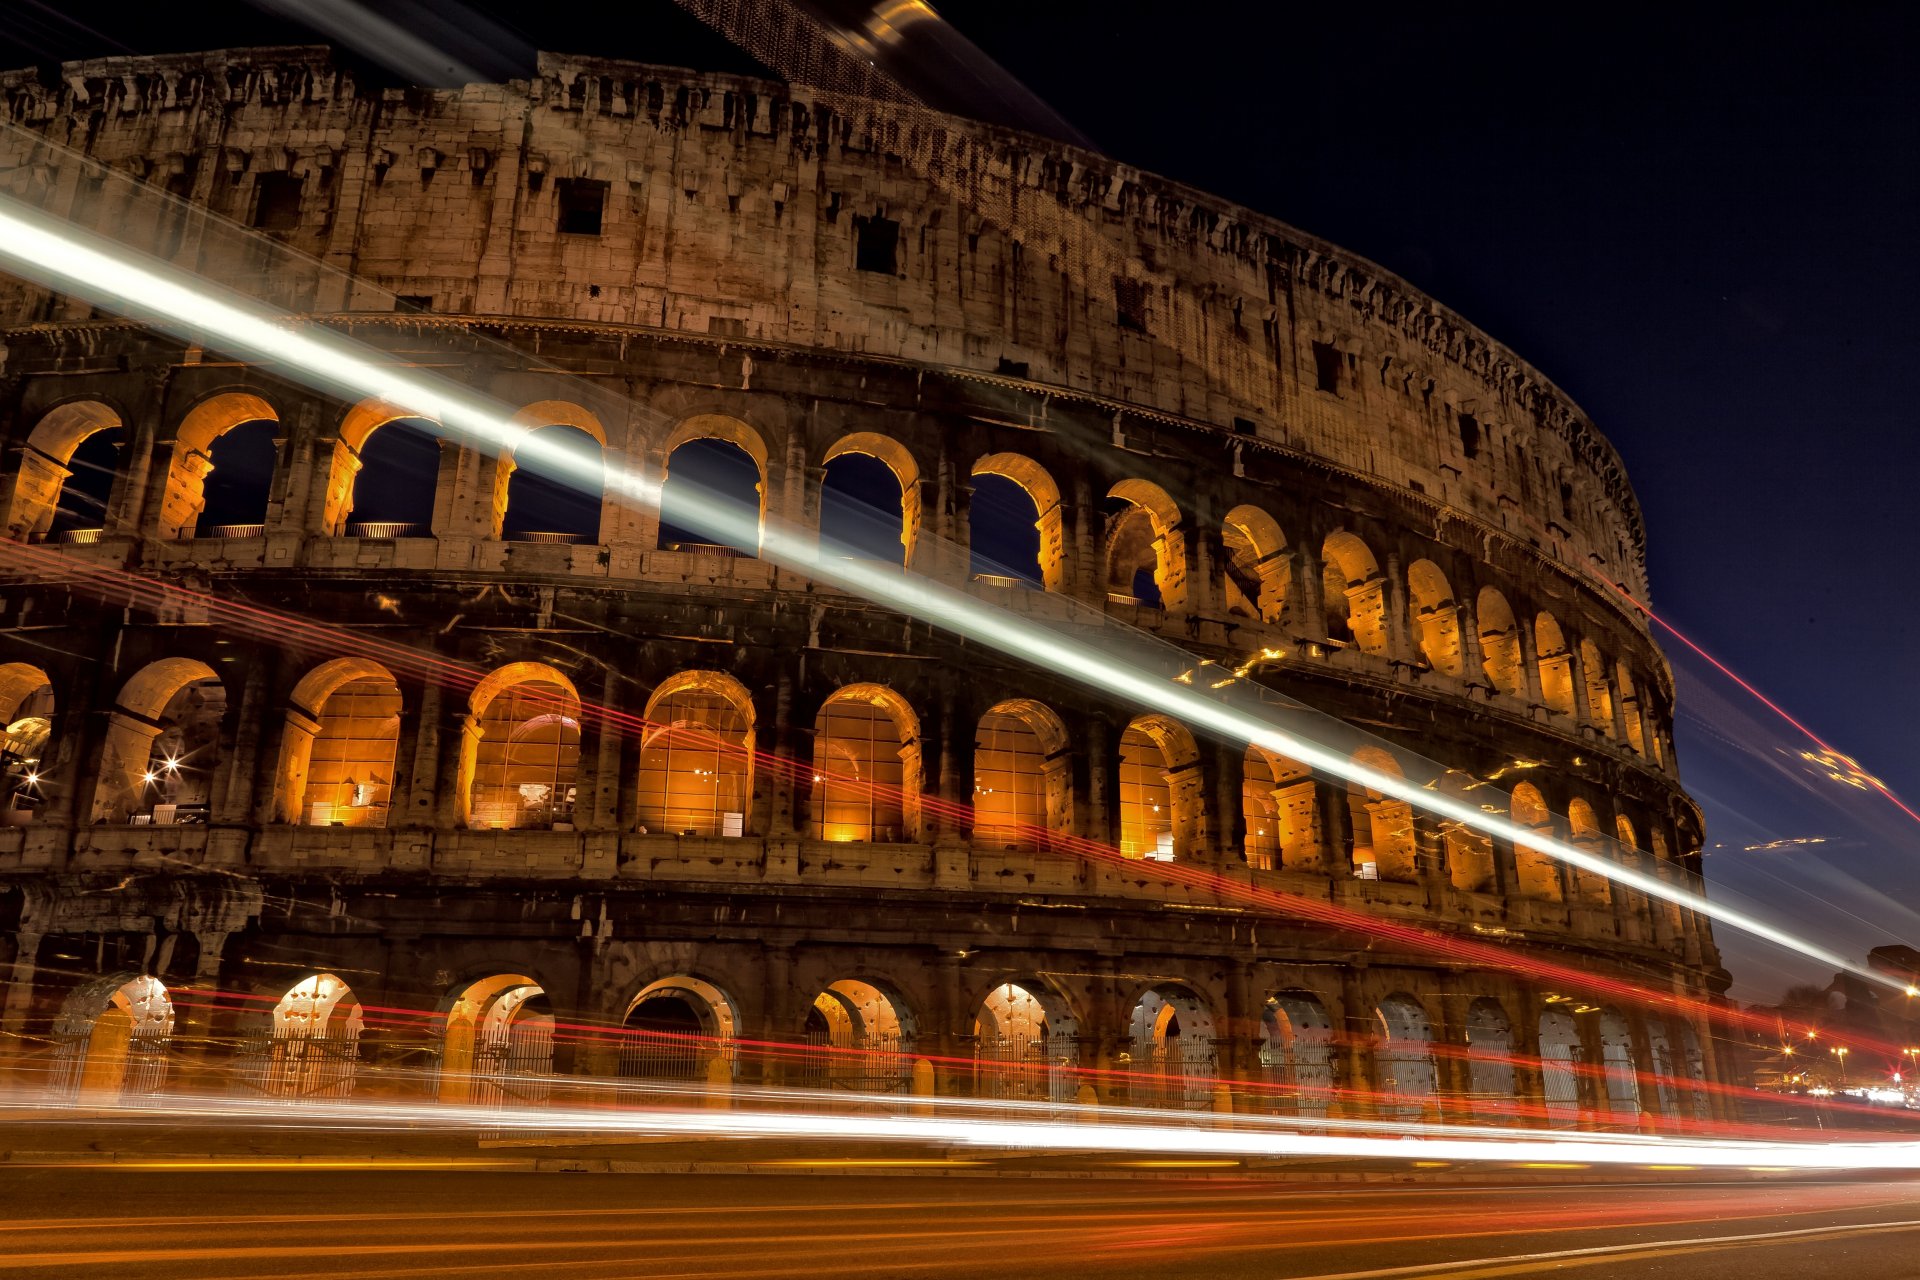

92,658,227,827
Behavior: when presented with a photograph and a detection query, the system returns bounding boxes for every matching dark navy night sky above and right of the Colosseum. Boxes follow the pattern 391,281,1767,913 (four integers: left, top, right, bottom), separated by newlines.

0,0,1920,1000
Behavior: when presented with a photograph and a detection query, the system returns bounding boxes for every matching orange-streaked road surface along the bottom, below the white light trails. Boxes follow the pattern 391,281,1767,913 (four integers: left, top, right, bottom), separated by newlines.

0,1161,1920,1280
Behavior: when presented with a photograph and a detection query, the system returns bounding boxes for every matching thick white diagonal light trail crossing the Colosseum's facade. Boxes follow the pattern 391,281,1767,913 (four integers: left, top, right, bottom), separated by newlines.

0,200,1905,988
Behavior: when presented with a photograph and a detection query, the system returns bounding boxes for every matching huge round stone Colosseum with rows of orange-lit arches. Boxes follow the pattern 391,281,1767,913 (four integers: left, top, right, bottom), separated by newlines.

0,46,1734,1125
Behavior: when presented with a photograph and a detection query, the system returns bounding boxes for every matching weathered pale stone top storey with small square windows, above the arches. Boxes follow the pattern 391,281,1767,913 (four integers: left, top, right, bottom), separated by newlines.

0,46,1645,593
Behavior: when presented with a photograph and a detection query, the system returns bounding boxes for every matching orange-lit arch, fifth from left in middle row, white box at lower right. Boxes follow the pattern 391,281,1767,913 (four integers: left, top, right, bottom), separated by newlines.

639,672,755,837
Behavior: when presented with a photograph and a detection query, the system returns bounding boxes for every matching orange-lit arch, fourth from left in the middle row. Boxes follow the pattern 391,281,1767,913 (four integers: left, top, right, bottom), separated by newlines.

461,662,580,831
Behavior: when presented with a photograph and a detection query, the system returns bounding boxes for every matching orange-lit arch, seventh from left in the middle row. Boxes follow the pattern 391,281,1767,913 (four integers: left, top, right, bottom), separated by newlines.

973,699,1073,850
